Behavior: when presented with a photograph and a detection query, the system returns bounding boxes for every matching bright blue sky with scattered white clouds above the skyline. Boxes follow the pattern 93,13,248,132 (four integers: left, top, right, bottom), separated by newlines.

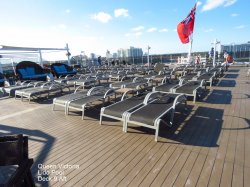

0,0,250,59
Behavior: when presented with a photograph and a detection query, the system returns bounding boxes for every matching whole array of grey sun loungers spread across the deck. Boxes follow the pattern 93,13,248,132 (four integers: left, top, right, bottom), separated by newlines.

0,62,226,141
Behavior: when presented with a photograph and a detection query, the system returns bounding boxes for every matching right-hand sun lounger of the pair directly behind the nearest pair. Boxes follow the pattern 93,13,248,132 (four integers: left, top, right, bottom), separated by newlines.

172,80,206,103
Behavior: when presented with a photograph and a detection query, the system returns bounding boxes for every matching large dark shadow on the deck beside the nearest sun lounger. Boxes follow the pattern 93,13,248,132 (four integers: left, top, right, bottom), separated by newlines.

128,106,223,147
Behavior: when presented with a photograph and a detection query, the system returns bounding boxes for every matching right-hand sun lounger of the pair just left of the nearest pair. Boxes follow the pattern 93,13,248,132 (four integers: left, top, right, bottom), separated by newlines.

66,86,115,119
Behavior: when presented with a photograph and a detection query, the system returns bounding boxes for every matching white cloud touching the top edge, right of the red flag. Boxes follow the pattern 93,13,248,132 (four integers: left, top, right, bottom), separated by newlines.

201,0,237,12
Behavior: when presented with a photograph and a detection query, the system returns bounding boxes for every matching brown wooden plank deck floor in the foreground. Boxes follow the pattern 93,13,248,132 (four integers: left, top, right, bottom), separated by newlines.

0,67,250,187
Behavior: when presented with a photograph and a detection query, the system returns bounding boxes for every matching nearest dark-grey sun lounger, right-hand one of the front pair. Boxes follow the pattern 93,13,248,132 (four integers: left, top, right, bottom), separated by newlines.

124,93,186,141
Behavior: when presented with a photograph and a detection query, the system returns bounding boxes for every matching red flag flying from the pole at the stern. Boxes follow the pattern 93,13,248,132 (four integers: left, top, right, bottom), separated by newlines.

177,3,196,44
